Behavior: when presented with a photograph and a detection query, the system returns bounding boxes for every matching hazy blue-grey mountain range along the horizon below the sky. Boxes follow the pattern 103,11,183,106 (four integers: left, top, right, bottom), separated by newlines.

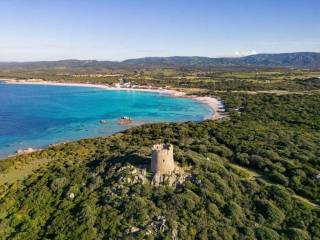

0,52,320,69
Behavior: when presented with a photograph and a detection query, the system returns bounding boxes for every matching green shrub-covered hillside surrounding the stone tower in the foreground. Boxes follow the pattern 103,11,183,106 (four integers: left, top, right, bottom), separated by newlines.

0,93,320,240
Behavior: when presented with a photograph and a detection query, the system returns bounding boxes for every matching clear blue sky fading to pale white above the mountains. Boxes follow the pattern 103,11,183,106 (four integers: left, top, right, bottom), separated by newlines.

0,0,320,61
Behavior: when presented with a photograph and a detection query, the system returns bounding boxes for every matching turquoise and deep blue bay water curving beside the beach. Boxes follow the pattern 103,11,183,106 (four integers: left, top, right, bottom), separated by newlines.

0,81,212,157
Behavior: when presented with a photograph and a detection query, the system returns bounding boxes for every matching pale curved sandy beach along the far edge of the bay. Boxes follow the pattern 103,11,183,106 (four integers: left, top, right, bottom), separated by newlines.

0,78,224,120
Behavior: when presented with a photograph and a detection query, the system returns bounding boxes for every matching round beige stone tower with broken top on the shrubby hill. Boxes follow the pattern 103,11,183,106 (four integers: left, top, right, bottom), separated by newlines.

151,144,175,174
